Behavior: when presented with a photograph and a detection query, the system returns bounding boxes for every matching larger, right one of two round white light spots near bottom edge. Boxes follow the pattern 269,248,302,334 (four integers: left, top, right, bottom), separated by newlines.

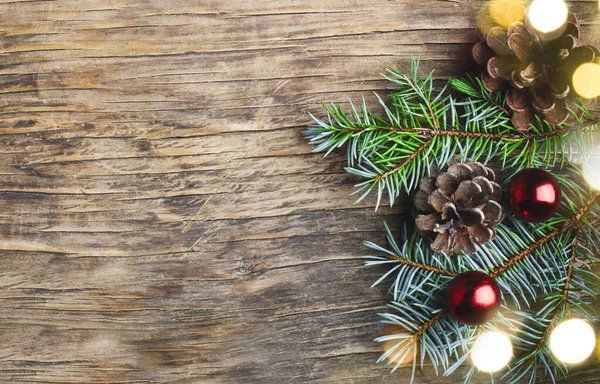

549,319,596,363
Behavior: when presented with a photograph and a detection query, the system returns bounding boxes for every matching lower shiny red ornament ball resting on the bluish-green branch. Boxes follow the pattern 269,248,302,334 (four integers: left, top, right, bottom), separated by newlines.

448,271,502,325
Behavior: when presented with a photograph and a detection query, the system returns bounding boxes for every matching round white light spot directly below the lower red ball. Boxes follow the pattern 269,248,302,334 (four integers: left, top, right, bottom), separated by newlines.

471,332,512,372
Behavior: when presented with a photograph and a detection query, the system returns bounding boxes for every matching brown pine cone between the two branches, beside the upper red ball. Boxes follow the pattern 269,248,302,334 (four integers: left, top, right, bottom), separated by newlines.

413,156,504,256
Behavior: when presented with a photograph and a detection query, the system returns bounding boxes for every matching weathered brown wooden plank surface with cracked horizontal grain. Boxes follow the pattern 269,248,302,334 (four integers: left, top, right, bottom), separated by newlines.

0,0,600,383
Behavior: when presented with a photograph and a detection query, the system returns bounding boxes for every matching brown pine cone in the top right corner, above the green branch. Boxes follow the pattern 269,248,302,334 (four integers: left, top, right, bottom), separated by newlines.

472,13,600,131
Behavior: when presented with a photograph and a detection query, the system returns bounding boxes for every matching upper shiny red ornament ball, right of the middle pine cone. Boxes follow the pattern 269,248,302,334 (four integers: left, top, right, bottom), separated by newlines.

507,168,560,223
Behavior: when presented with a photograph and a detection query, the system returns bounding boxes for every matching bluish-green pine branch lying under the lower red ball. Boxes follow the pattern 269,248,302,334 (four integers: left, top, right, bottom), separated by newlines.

365,167,600,384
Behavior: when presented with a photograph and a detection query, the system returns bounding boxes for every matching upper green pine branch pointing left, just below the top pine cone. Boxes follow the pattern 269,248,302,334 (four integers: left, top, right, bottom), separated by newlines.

305,57,600,207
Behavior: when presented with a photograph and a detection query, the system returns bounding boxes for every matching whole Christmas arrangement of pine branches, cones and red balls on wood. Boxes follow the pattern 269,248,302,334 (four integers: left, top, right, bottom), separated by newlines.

305,0,600,384
